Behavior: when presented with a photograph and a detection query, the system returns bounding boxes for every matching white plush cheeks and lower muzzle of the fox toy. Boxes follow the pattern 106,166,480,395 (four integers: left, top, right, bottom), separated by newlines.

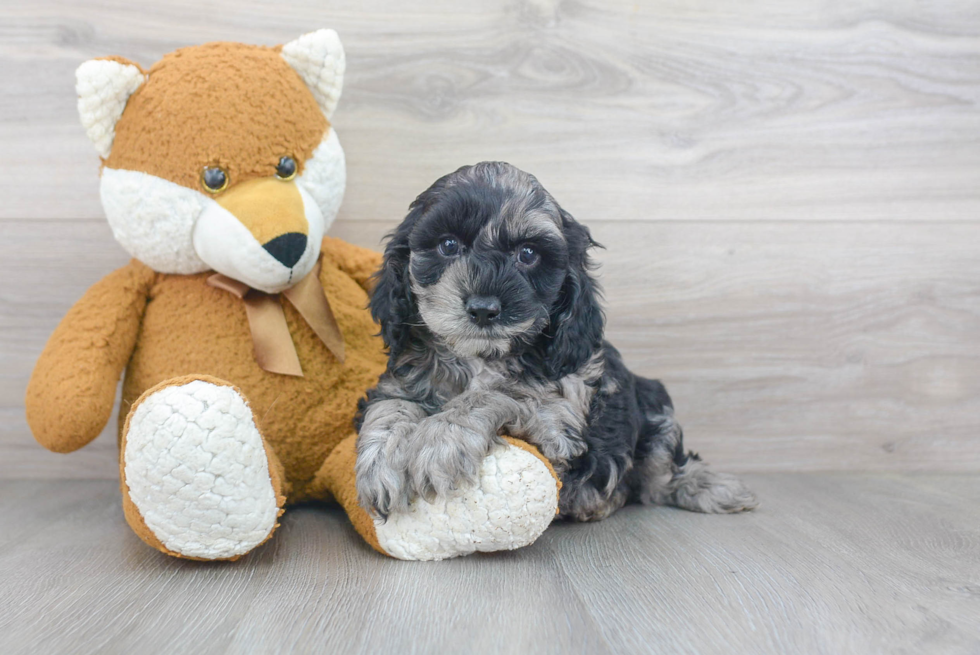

100,129,347,293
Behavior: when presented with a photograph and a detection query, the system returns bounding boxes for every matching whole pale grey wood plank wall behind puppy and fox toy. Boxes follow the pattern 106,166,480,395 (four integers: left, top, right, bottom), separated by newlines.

0,0,980,478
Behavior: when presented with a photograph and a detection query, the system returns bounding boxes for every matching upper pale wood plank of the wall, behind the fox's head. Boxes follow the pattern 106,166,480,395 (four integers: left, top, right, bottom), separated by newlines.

0,0,980,221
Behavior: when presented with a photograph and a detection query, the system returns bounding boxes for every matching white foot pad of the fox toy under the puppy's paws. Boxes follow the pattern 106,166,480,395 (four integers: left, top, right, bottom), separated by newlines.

375,444,558,560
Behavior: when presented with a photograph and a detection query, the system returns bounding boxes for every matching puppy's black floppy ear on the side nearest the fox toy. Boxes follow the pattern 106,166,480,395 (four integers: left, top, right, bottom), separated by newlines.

370,202,422,361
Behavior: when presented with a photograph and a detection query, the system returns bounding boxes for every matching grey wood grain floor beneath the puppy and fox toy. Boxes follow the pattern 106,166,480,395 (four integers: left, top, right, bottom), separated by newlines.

0,474,980,655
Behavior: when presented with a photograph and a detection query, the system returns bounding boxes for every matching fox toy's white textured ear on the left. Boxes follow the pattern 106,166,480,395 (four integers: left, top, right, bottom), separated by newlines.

75,58,146,159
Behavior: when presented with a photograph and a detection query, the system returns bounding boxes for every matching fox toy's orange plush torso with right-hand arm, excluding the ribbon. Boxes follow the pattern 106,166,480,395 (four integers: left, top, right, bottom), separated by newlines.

119,237,386,502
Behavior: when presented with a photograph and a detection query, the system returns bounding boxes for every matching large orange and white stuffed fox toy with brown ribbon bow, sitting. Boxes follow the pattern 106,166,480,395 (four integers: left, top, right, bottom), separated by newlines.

26,30,558,560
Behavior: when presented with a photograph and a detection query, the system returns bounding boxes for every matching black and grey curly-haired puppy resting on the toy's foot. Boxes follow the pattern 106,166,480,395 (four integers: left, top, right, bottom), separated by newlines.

356,162,756,521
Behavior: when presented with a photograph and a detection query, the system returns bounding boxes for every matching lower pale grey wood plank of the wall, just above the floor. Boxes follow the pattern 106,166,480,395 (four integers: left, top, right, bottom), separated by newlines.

0,221,980,479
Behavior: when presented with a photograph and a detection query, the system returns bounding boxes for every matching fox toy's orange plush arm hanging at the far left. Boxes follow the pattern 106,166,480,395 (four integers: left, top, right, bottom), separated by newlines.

25,260,155,452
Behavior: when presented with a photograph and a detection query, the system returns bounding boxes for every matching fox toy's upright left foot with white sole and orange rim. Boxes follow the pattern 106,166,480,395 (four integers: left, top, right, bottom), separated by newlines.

119,376,285,560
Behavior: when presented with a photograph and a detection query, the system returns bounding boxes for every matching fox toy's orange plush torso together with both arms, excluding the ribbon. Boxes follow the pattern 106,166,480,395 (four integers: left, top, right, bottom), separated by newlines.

26,237,386,502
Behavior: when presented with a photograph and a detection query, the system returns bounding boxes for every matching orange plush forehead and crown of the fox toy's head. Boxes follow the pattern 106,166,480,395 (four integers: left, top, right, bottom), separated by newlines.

105,43,329,189
